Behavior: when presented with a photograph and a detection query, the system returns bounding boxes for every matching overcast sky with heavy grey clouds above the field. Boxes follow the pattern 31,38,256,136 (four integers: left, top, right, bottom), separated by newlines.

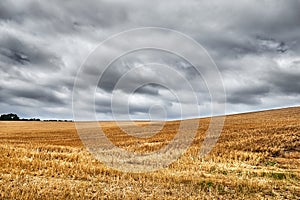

0,0,300,120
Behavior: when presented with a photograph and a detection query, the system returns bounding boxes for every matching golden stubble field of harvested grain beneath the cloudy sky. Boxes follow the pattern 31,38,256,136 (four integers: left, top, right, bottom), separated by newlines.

0,107,300,199
